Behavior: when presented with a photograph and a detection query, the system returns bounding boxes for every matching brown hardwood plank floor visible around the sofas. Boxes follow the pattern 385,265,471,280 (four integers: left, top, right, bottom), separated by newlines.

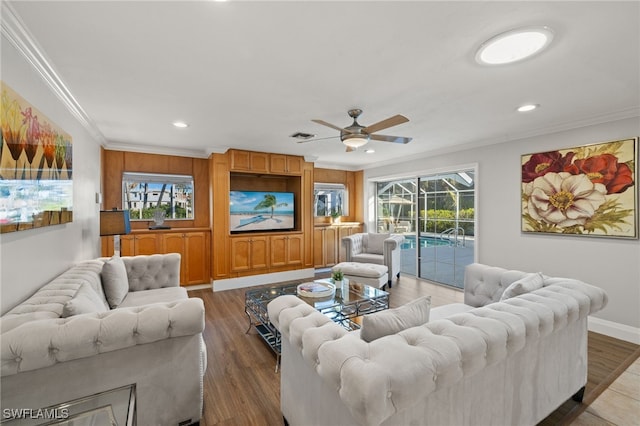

189,276,640,426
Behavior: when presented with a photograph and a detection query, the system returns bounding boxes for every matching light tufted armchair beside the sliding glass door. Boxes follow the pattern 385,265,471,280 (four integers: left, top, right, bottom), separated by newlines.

342,233,404,287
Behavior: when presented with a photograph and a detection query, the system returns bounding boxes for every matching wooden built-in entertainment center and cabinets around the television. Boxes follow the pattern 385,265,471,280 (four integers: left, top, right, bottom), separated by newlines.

102,149,362,290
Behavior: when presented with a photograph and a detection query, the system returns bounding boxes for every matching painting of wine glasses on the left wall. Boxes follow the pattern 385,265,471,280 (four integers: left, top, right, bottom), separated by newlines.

0,82,73,233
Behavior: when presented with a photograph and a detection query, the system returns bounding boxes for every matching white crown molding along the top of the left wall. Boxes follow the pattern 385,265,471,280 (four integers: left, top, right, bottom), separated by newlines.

0,1,107,146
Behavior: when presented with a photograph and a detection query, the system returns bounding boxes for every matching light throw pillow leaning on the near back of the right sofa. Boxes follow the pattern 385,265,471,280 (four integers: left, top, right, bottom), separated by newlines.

360,296,431,342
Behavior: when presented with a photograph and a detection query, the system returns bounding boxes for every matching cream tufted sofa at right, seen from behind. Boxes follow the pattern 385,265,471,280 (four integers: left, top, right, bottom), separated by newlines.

268,264,607,426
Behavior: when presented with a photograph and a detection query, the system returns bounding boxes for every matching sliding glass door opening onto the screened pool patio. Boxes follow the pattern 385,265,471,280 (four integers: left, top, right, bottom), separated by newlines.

376,169,475,288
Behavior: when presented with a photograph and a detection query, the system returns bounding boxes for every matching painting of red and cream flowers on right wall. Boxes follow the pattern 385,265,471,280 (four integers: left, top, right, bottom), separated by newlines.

522,138,638,238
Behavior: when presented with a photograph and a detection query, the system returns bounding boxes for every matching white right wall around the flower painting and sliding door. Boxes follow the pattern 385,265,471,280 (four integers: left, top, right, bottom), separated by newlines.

364,118,640,333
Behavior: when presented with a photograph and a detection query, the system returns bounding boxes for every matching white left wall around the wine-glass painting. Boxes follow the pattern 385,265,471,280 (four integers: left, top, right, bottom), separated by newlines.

0,36,100,313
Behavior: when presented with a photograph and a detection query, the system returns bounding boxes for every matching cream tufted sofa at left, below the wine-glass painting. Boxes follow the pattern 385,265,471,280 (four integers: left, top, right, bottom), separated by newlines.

0,253,206,425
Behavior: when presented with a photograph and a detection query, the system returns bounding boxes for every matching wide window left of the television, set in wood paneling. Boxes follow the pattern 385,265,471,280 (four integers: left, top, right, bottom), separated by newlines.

122,172,194,220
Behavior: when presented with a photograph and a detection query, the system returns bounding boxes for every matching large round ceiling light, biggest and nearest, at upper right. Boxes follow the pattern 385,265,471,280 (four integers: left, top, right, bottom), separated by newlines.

476,27,553,65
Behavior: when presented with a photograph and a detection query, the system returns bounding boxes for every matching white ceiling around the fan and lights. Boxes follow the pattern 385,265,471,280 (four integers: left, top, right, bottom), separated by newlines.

3,0,640,169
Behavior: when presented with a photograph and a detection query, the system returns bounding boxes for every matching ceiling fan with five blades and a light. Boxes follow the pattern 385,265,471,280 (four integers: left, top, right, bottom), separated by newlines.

298,109,411,152
